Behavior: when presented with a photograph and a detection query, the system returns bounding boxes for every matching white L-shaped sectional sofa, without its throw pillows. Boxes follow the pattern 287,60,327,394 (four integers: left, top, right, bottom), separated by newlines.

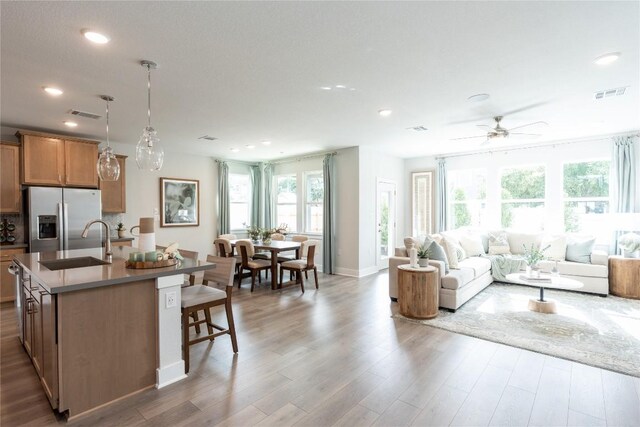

389,230,609,311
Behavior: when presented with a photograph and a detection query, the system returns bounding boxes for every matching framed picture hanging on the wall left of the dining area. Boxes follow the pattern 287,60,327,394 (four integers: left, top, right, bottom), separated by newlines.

160,178,200,227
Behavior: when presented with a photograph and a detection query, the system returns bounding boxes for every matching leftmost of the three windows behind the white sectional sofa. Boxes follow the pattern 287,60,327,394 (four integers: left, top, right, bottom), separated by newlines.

447,169,487,228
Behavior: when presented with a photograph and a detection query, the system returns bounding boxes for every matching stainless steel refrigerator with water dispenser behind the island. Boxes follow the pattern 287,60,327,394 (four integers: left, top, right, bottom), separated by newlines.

25,187,102,252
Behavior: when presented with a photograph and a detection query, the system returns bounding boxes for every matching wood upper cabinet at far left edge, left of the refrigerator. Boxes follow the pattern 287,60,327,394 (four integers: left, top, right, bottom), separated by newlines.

0,142,22,213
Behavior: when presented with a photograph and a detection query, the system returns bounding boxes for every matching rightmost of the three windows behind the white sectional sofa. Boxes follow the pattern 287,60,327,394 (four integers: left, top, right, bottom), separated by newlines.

563,160,610,239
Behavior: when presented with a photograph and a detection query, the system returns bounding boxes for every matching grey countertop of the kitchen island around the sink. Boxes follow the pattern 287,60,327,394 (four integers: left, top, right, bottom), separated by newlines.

13,247,215,294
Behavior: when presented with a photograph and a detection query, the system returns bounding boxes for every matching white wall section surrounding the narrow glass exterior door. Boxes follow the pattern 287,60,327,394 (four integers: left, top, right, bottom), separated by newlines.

358,147,407,276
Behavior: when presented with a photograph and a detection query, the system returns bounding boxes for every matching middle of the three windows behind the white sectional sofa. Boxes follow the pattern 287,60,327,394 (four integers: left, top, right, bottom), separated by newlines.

500,166,545,231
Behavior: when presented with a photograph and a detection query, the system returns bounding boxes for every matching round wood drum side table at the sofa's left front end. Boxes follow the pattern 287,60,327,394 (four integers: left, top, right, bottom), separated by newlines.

398,264,440,319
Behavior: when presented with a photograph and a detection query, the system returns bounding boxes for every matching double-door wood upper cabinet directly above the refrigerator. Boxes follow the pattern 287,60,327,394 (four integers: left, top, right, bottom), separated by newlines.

16,131,98,188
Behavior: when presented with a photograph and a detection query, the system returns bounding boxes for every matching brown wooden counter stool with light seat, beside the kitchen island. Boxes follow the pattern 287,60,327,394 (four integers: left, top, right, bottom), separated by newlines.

180,255,238,373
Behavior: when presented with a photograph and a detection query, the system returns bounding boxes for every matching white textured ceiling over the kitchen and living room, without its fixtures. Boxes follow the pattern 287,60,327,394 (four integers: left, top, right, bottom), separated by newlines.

0,1,640,160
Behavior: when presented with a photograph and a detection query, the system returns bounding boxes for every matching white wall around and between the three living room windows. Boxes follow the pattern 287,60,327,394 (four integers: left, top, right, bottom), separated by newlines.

405,137,640,235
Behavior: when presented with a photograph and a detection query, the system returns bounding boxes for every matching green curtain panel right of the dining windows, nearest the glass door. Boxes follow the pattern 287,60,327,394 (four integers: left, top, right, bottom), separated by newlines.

322,153,337,274
